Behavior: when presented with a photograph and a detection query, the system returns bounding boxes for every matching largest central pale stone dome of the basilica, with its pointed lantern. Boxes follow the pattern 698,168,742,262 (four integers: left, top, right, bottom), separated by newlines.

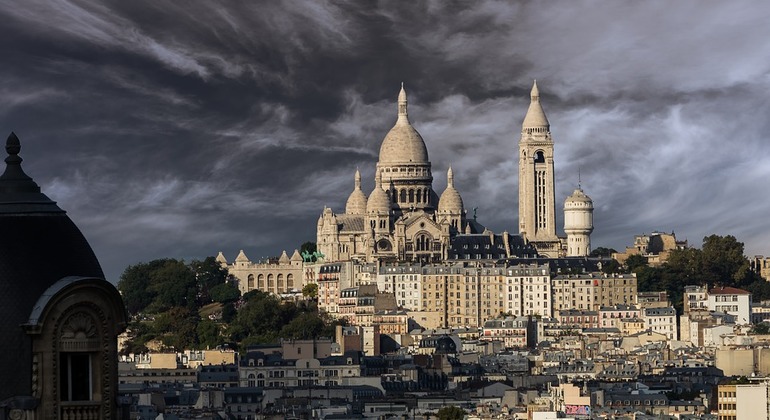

379,84,428,164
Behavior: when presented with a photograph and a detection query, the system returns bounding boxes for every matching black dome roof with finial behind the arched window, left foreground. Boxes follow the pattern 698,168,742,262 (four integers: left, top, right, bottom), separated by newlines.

0,133,104,401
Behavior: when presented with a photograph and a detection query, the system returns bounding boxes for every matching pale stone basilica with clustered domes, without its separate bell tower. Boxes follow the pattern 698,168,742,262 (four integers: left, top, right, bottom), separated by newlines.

317,85,468,262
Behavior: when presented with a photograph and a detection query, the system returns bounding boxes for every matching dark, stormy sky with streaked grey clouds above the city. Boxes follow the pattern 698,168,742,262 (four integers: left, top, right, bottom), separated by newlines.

0,0,770,282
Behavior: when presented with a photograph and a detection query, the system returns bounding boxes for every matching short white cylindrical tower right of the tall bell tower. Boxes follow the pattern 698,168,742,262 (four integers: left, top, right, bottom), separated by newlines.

564,188,594,257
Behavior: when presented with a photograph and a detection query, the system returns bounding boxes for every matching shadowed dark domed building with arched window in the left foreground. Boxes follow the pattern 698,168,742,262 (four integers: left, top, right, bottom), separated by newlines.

0,133,127,419
